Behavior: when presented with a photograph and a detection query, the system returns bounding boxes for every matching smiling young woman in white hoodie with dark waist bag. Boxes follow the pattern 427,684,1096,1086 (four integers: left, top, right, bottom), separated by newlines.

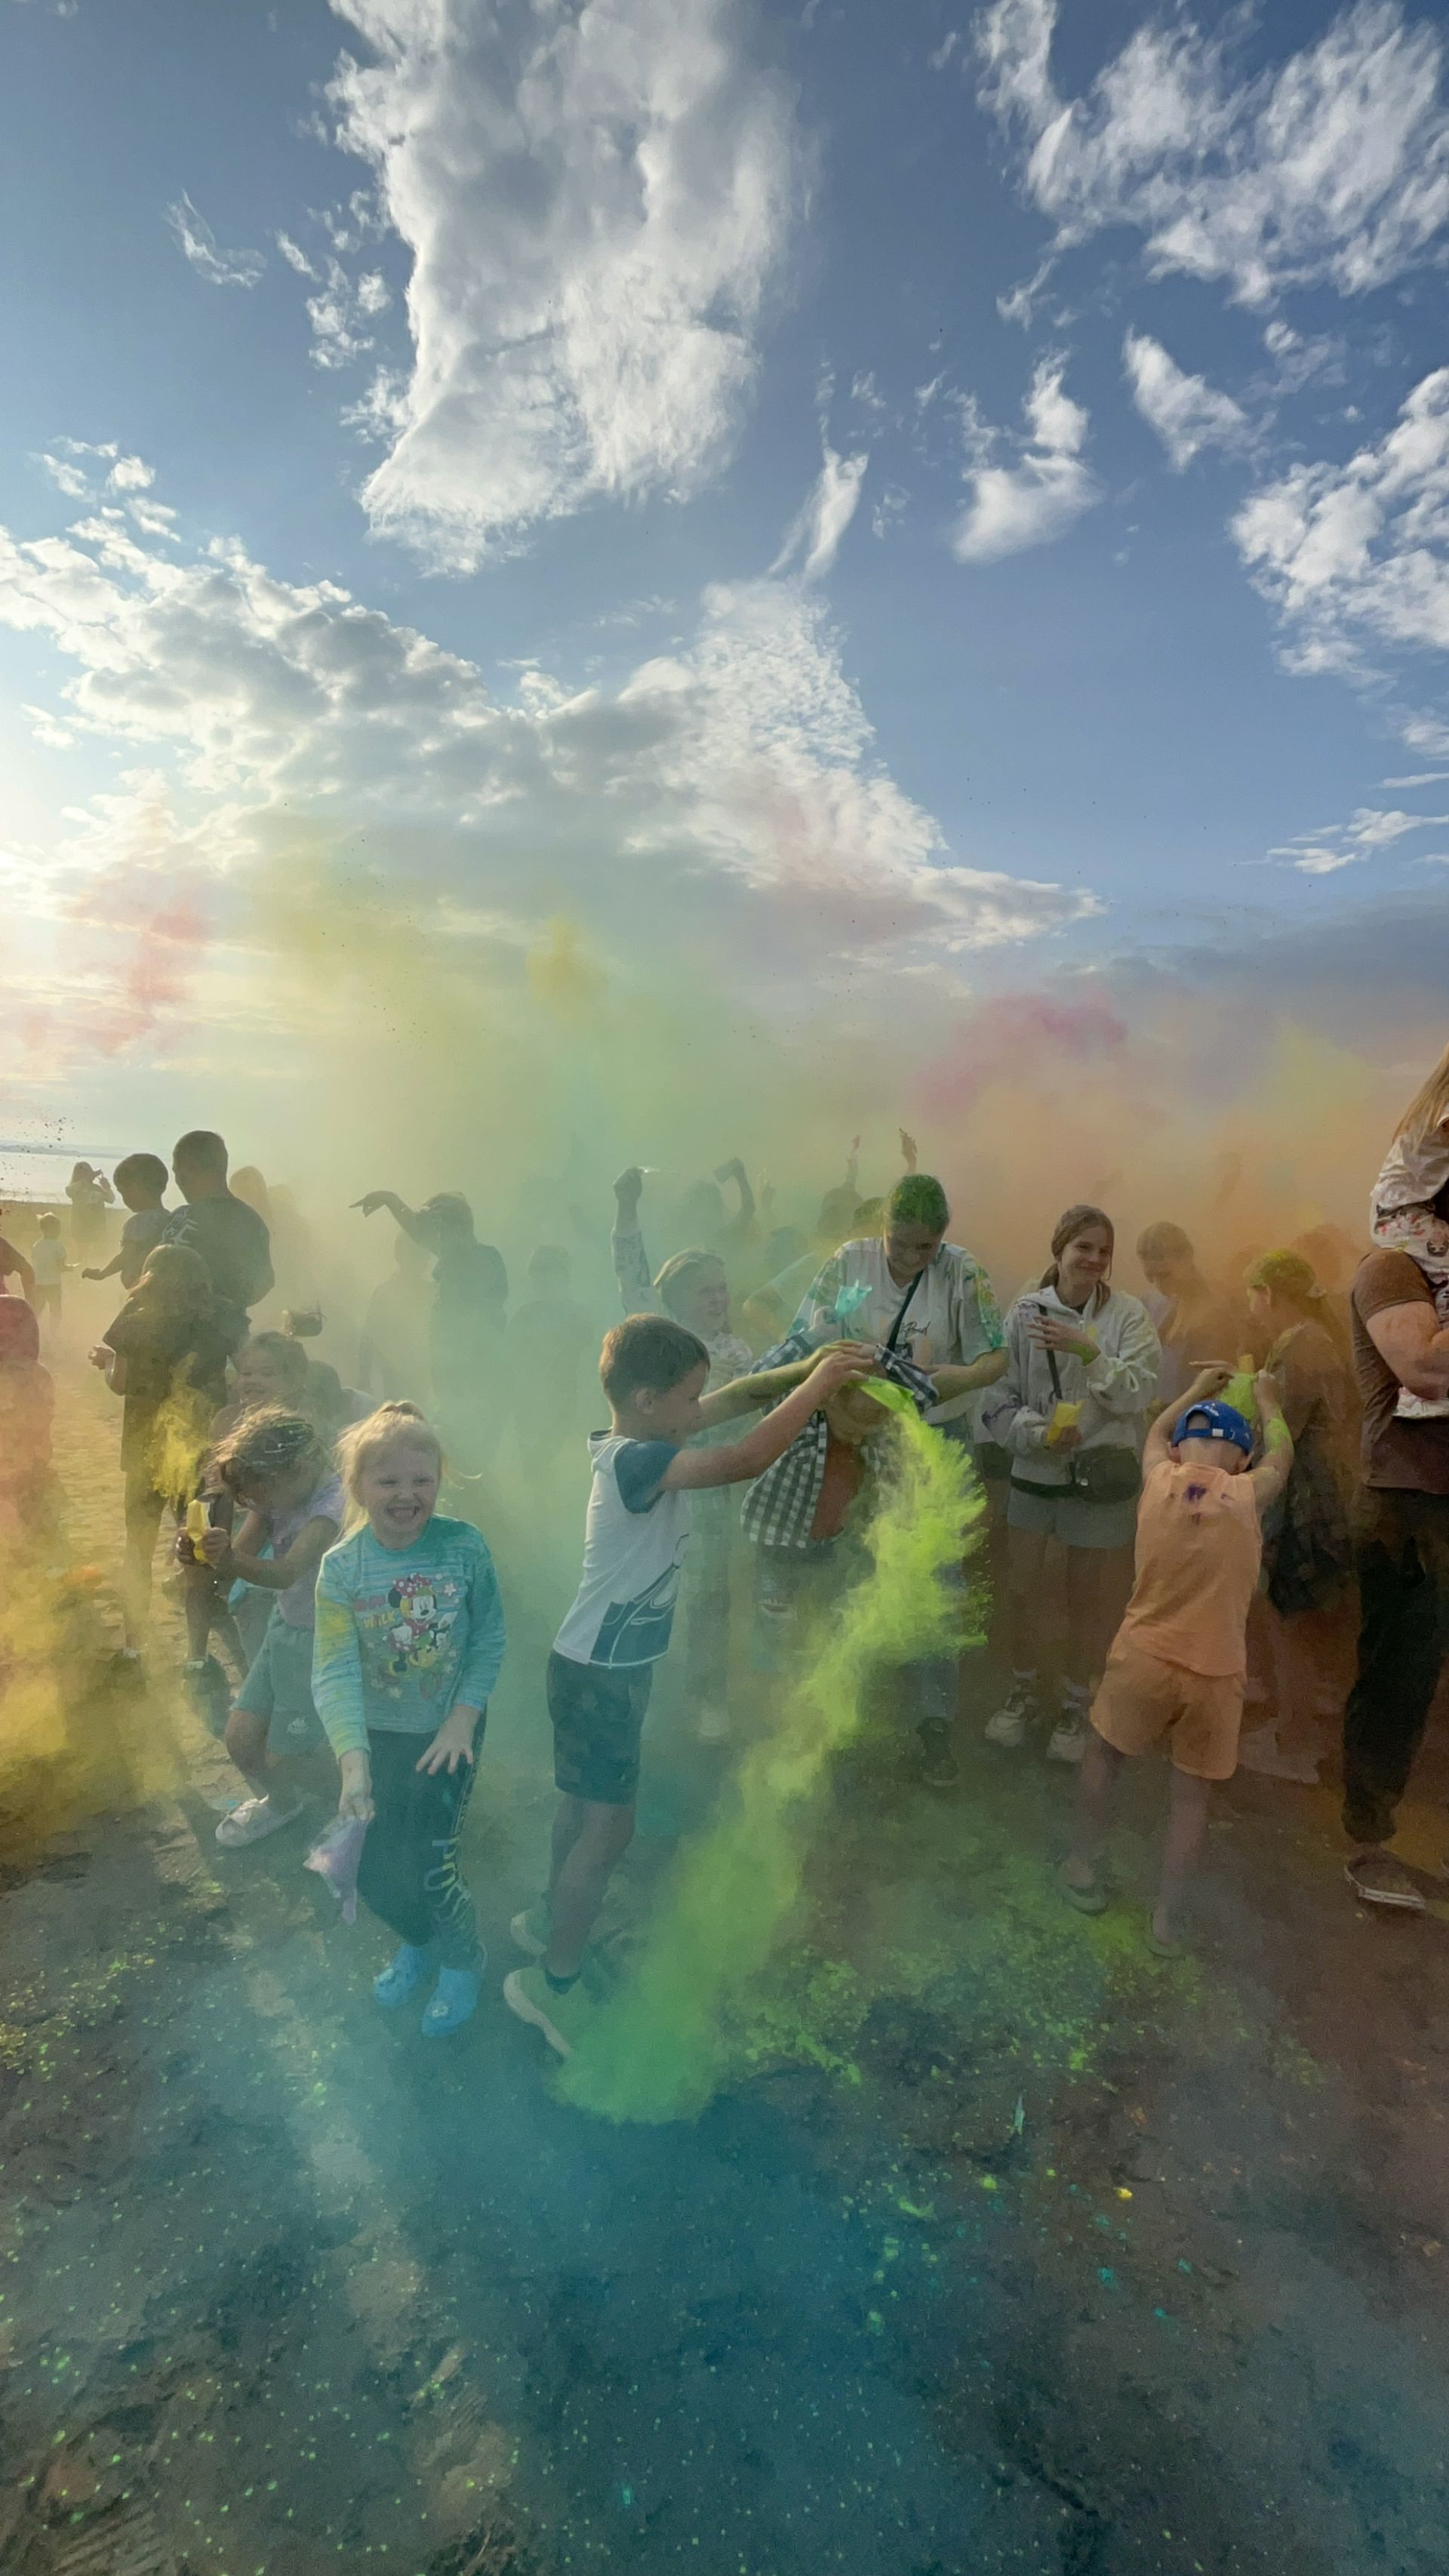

983,1205,1163,1762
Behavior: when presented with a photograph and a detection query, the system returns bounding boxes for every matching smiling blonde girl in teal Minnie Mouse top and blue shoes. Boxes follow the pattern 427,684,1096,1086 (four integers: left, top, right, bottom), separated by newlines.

312,1404,504,2040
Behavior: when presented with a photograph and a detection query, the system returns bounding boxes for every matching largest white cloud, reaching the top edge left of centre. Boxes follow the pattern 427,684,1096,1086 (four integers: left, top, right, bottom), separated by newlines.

330,0,795,569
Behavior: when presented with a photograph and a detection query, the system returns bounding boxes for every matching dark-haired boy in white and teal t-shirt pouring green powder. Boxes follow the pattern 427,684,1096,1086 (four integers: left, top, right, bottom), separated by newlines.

504,1314,875,2058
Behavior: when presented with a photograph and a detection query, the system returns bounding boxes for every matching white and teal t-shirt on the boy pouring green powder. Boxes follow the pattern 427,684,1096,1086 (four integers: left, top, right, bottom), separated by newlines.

553,1433,690,1664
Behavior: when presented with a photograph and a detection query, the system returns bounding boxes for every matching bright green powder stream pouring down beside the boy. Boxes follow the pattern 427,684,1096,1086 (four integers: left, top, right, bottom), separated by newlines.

558,1414,983,2120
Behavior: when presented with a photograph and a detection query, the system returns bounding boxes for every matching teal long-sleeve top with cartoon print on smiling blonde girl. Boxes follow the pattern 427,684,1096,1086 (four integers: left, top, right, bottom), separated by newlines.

312,1512,504,1759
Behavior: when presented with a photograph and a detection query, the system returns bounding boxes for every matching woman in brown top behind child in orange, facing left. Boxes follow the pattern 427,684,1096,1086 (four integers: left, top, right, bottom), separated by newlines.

1238,1252,1359,1785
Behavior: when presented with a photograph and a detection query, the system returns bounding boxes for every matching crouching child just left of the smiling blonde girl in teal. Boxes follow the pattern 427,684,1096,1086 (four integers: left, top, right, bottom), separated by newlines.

195,1404,343,1852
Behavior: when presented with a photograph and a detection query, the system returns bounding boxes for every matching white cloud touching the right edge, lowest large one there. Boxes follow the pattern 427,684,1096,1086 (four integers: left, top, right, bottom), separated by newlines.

1230,368,1449,680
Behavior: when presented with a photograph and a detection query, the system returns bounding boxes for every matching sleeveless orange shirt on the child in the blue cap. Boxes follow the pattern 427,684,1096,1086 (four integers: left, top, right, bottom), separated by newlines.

1119,1458,1263,1677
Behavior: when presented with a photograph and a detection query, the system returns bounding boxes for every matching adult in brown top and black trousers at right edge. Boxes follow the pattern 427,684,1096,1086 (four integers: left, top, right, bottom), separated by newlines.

1343,1190,1449,1914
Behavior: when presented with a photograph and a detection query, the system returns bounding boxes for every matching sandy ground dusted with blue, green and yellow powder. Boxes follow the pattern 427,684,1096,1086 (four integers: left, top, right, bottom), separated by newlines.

0,1350,1449,2576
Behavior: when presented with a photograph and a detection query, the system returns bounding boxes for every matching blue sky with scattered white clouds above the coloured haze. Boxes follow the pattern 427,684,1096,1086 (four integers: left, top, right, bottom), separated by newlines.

0,0,1449,1149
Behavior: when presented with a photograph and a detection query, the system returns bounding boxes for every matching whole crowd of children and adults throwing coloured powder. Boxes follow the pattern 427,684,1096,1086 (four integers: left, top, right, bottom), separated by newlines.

0,1051,1449,2056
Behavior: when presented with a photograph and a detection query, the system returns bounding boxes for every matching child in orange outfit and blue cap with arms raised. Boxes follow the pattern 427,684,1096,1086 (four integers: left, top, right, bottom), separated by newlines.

1060,1368,1292,1958
